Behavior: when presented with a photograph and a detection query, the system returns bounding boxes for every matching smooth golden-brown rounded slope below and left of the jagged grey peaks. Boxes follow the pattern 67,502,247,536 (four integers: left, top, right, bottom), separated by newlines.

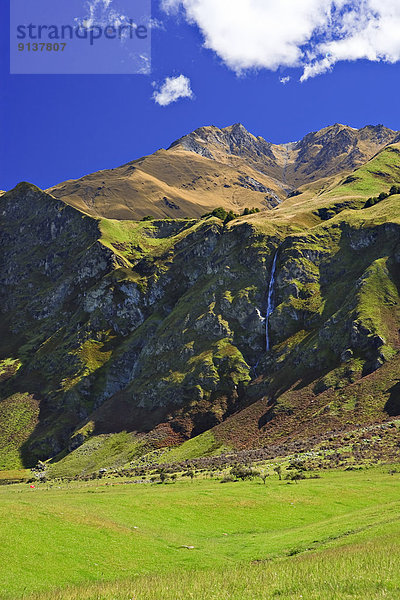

48,147,286,219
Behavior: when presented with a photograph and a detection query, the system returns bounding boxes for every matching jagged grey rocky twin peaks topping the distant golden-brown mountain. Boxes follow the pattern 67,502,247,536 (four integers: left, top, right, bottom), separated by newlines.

170,123,398,185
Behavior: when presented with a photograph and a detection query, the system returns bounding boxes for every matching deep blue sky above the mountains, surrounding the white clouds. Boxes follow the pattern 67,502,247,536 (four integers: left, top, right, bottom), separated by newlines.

0,0,400,189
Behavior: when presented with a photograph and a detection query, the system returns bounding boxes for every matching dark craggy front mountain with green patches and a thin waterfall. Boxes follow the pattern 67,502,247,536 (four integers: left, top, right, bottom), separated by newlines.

0,126,400,473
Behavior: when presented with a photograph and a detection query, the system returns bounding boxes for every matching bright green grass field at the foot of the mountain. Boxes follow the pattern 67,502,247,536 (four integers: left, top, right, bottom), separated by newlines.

0,467,400,600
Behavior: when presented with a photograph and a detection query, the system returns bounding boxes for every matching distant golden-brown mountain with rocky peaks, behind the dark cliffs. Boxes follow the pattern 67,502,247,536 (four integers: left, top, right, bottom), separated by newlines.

48,123,399,219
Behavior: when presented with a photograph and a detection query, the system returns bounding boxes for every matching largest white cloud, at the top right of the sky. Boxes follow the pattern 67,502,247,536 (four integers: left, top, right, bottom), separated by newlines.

160,0,400,81
